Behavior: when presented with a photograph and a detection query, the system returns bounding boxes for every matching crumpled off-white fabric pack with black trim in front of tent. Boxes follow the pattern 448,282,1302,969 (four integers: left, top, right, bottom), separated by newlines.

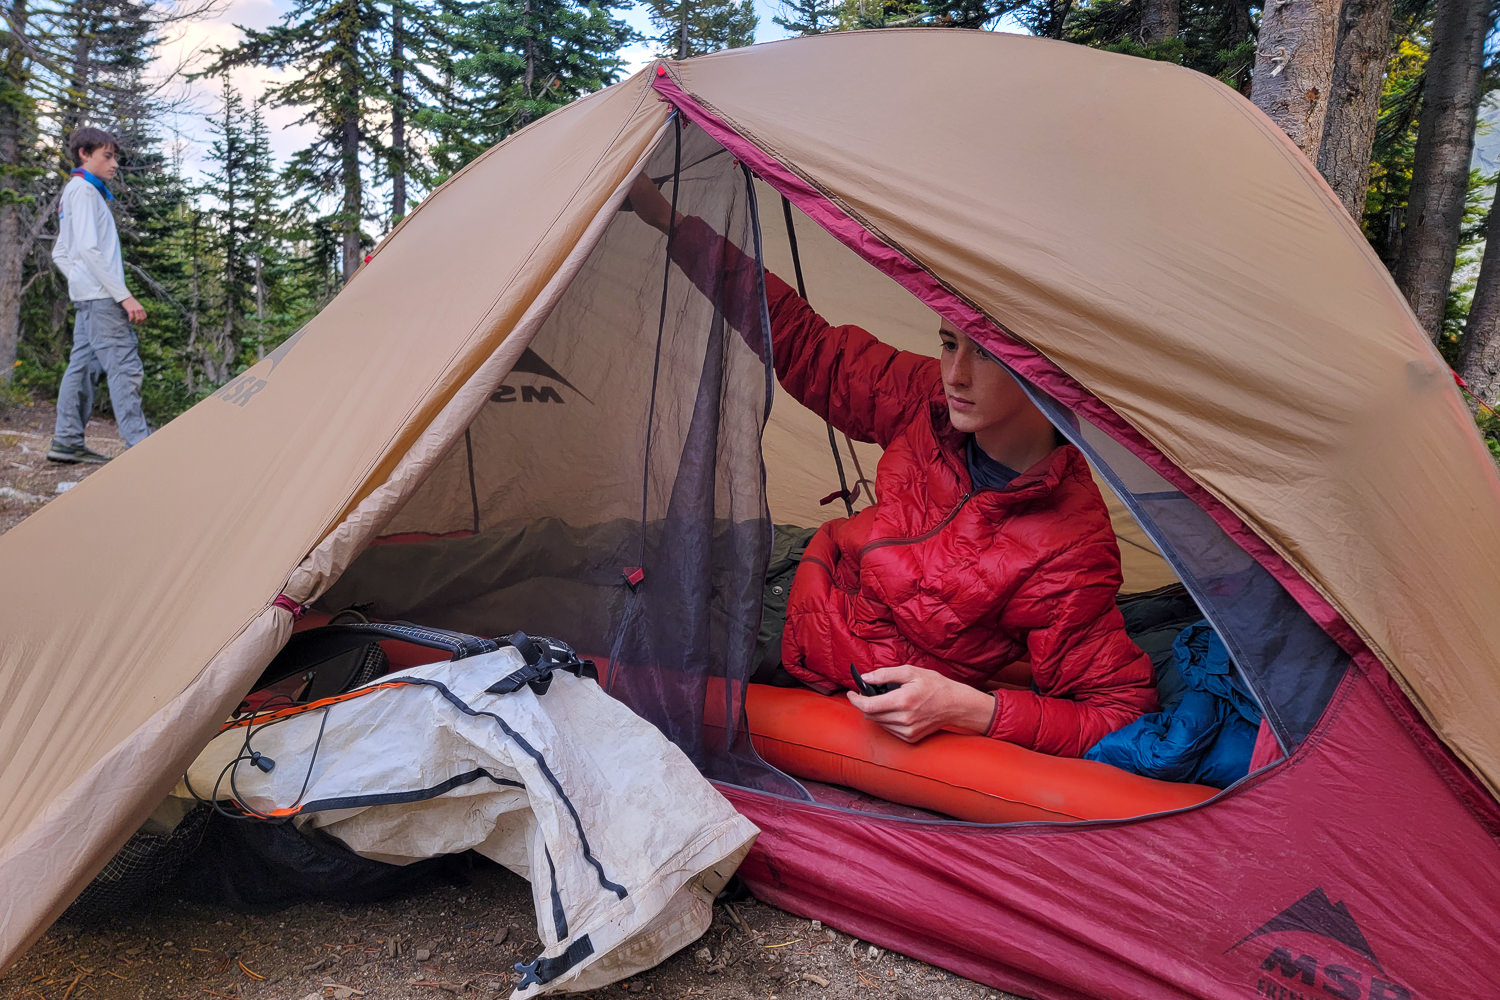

177,648,759,997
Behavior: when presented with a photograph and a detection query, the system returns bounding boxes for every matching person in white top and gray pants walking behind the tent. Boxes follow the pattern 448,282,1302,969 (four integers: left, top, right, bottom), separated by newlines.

47,127,152,463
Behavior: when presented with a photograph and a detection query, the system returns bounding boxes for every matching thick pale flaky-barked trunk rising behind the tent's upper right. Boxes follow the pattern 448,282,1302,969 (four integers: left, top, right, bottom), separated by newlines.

1250,0,1340,163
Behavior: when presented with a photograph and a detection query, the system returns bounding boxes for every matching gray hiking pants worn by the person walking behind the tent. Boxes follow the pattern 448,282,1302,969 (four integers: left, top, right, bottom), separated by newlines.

53,298,152,448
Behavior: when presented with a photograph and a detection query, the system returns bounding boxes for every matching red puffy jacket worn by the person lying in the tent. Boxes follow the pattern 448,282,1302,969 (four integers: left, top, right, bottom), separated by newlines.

672,219,1157,757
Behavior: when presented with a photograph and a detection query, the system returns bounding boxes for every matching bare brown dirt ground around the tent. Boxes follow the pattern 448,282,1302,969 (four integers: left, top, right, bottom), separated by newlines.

0,402,1019,1000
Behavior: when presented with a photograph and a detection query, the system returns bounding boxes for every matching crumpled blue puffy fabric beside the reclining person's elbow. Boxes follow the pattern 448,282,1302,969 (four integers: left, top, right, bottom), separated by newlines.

1085,622,1260,789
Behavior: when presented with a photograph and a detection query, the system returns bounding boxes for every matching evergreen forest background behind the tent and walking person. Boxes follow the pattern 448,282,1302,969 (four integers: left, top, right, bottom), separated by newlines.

0,0,1500,459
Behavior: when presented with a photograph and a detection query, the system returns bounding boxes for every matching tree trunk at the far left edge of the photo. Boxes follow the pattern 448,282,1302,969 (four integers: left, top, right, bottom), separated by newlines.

0,0,27,385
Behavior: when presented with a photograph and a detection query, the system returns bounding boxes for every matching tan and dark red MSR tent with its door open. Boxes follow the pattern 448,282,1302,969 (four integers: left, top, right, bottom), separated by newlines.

0,30,1500,1000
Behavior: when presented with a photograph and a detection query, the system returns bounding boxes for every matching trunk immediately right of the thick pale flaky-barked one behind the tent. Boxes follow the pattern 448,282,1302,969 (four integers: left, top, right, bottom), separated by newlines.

1317,0,1395,222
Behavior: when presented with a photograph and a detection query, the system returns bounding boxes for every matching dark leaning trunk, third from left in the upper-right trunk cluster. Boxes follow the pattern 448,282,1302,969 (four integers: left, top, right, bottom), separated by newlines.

1395,0,1491,340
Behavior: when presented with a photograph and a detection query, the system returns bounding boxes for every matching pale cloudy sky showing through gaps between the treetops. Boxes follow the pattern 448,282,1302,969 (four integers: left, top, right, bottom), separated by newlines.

158,0,786,185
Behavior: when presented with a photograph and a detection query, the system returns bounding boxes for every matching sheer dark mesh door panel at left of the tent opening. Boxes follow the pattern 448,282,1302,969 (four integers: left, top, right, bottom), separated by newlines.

323,127,804,796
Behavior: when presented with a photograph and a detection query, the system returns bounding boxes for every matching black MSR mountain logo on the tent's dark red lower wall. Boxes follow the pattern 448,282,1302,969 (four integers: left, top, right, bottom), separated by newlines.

1224,888,1415,1000
